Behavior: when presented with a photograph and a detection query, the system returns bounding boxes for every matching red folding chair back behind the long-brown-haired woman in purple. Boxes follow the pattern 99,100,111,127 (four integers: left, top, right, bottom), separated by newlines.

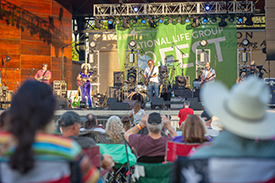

166,141,208,162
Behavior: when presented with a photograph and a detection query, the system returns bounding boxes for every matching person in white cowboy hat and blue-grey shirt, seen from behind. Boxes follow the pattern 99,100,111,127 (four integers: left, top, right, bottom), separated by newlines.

191,76,275,158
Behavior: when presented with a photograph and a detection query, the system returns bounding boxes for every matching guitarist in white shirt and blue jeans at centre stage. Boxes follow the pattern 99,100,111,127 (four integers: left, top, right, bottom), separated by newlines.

144,59,159,102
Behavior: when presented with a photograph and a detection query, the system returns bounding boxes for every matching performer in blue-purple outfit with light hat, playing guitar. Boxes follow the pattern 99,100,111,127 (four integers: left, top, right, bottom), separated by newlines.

76,63,92,107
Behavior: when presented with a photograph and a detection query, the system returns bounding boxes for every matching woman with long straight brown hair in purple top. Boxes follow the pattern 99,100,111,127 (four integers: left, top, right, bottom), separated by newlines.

172,115,212,144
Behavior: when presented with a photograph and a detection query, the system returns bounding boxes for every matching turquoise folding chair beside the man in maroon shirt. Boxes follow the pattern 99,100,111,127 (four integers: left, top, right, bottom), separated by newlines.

97,133,137,183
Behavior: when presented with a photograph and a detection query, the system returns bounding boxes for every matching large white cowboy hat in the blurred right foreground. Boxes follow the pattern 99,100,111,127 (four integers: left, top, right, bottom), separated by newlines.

201,76,275,139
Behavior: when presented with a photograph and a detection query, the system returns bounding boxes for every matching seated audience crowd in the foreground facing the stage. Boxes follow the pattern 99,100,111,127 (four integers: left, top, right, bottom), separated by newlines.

0,77,275,182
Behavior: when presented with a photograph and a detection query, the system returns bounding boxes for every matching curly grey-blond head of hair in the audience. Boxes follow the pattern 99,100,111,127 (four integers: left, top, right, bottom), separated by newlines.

105,116,125,144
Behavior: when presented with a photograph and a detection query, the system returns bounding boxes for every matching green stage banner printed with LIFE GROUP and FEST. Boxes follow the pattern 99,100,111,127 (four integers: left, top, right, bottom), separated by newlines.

116,21,237,87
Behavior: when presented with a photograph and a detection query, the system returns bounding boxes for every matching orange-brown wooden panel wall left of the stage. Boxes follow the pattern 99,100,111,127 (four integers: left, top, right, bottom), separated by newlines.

0,0,72,90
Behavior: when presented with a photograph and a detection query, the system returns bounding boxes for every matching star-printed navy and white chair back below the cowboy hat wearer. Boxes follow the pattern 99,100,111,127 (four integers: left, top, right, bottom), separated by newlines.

172,157,275,183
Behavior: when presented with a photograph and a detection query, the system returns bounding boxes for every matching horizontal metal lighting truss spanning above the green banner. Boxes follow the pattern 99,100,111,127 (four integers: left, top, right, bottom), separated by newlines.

94,1,255,17
